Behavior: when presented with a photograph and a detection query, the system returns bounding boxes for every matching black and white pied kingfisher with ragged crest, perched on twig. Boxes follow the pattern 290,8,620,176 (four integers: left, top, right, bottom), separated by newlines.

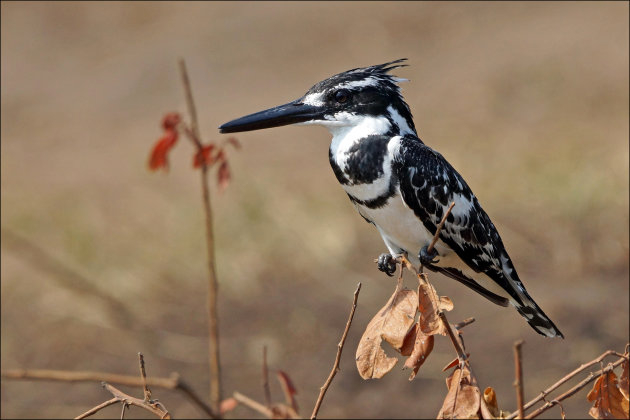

219,59,563,337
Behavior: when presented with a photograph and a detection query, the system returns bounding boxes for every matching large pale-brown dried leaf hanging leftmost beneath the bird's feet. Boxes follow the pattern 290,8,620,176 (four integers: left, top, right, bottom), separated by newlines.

356,289,418,379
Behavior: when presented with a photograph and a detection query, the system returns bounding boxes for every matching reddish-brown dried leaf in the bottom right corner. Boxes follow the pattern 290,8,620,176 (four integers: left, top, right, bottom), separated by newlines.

586,370,628,419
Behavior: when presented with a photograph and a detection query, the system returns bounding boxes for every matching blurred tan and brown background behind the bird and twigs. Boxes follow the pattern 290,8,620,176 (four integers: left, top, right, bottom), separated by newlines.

1,2,629,418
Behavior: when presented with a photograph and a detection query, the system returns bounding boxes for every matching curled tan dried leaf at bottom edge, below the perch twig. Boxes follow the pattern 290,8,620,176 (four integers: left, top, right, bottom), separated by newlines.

437,366,481,419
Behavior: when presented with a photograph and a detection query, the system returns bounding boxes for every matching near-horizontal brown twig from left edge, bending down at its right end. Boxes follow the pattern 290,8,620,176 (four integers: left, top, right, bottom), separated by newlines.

2,369,218,418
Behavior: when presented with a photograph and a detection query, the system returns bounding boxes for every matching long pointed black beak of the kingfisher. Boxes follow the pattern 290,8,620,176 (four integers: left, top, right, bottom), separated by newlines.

219,98,322,133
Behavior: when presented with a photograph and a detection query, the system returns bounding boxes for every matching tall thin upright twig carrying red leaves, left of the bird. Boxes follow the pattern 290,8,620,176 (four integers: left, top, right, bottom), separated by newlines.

179,59,221,413
